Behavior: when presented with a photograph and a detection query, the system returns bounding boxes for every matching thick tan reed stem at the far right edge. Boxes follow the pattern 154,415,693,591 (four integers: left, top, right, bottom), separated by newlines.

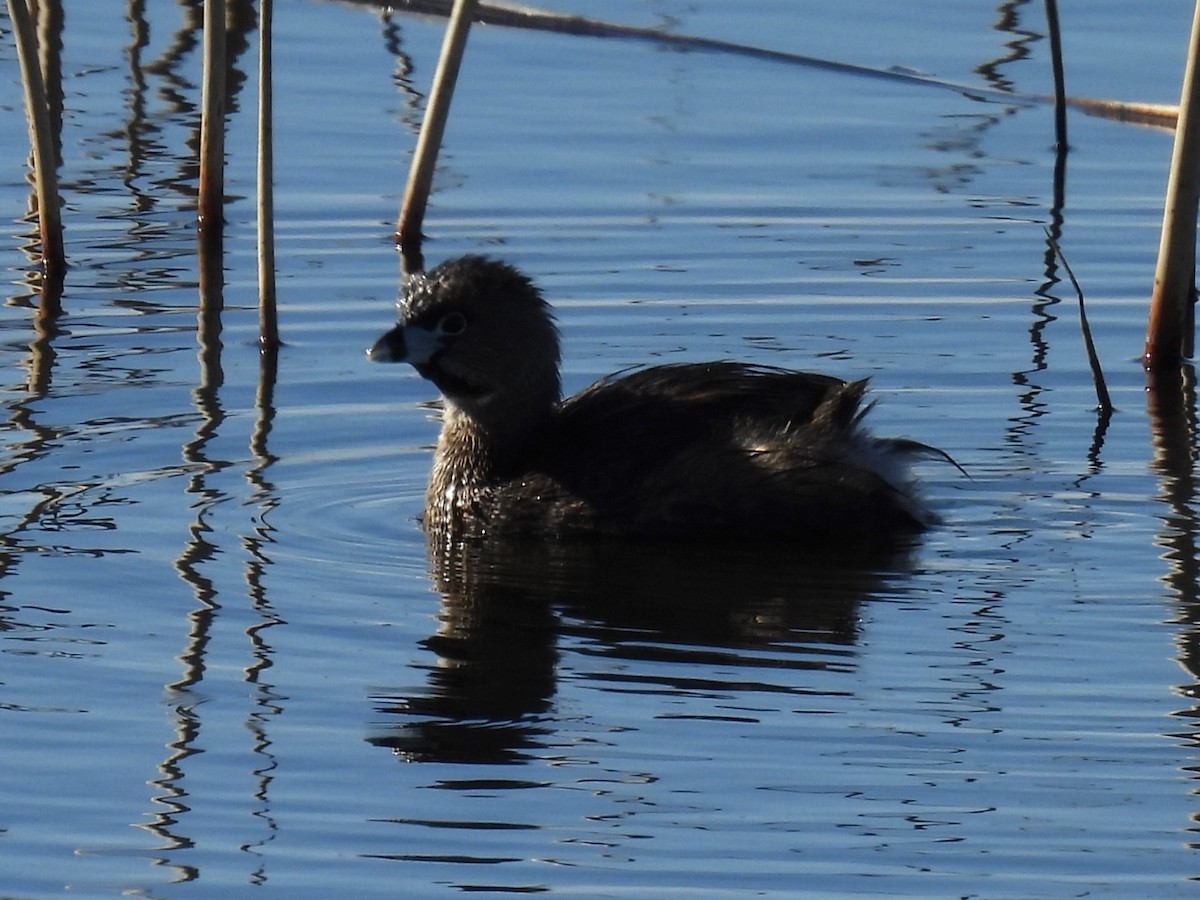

1141,0,1200,372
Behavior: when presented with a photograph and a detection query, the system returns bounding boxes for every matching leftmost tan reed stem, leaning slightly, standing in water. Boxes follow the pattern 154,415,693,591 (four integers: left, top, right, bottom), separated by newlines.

8,0,67,314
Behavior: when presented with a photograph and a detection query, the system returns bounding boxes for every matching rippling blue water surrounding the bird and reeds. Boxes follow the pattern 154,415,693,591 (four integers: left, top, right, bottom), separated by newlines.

0,0,1200,900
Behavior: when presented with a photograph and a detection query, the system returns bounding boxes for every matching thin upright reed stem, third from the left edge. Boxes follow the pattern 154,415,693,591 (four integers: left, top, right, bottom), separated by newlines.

258,0,280,348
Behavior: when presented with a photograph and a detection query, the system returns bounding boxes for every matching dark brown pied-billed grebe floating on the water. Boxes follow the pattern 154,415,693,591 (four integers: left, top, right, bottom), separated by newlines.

368,256,941,542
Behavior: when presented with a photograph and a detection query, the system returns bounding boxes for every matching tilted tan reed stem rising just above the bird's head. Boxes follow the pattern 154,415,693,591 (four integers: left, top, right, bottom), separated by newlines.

396,0,479,274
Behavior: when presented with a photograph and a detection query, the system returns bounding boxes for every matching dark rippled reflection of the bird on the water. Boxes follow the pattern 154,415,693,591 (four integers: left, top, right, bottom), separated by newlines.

368,541,911,763
